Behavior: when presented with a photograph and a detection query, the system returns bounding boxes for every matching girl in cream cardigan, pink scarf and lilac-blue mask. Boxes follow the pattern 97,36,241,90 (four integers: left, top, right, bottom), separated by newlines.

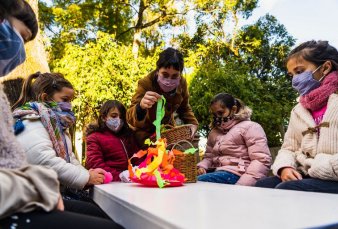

256,41,338,193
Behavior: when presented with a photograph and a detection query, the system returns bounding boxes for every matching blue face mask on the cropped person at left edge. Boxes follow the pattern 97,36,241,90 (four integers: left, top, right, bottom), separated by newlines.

0,20,26,77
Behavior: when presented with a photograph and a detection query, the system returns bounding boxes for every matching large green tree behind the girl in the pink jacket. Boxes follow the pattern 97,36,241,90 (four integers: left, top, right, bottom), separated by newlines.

185,15,296,146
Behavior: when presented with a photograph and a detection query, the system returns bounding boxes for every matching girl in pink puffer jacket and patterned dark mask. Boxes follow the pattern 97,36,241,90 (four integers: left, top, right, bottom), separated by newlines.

197,93,271,186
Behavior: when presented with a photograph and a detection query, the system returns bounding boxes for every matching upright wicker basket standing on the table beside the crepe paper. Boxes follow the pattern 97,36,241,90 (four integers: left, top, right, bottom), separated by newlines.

168,140,198,183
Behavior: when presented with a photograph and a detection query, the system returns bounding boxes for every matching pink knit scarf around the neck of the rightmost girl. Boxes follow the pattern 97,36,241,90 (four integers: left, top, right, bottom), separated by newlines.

300,71,338,111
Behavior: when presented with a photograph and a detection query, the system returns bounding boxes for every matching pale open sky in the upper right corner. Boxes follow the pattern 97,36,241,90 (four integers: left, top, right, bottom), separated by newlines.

249,0,338,48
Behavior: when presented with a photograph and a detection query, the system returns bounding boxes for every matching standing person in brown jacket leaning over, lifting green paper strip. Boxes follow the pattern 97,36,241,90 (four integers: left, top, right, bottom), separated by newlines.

127,48,198,146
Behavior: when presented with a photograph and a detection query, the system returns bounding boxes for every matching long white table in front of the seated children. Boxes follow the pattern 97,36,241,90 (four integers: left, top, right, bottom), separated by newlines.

92,182,338,229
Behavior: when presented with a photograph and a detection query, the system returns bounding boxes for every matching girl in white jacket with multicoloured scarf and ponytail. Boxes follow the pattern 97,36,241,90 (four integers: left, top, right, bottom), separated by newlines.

13,72,105,198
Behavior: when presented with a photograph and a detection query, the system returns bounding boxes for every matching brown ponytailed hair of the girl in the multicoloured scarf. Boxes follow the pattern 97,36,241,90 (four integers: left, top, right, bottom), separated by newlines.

12,72,73,110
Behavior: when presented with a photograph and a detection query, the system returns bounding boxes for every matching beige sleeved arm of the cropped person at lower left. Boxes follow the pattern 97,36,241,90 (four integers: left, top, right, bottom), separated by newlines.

0,165,60,218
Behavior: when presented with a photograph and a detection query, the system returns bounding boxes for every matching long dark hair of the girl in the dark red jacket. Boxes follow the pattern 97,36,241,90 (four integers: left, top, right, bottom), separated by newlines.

86,100,131,136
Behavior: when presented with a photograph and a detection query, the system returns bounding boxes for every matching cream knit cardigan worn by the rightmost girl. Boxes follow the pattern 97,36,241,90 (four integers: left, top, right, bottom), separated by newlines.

272,94,338,181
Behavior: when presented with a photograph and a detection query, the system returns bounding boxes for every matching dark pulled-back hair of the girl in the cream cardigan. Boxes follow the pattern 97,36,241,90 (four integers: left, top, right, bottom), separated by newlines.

286,40,338,71
